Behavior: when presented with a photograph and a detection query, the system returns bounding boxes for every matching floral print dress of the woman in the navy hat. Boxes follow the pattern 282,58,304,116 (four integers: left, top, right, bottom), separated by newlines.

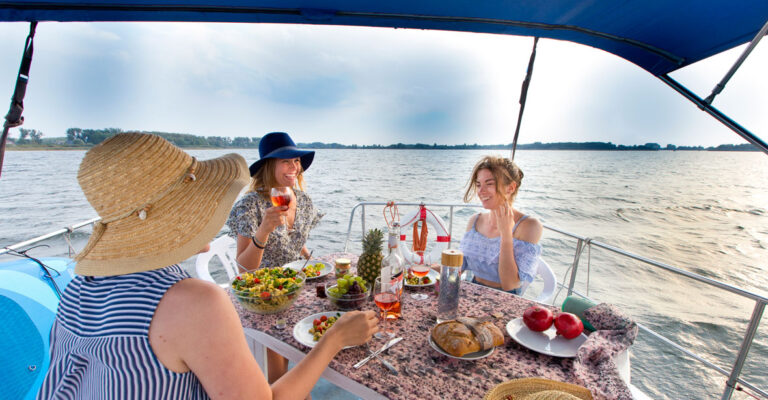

227,189,324,269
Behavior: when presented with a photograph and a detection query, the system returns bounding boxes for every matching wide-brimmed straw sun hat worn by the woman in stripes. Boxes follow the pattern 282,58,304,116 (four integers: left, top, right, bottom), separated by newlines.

75,133,248,276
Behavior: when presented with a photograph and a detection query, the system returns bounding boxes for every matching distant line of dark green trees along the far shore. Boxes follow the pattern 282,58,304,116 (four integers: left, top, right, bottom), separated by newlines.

3,128,758,151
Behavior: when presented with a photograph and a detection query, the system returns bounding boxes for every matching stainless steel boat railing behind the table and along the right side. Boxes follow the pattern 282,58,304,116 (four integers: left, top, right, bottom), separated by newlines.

344,202,768,400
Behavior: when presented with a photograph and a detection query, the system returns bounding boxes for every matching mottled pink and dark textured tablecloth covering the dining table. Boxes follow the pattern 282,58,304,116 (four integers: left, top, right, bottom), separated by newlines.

233,253,637,399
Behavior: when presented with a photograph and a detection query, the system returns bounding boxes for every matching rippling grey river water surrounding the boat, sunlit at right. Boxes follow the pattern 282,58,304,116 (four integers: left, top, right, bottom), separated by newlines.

0,150,768,398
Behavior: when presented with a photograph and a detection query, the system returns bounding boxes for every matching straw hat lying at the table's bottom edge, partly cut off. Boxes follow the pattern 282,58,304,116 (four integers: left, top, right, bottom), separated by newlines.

483,378,592,400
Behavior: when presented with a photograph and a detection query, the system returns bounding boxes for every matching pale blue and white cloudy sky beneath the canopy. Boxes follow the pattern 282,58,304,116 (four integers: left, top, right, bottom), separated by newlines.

0,22,768,146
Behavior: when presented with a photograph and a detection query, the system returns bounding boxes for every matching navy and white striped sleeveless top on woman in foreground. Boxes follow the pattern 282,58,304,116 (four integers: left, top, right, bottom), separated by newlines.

37,265,208,399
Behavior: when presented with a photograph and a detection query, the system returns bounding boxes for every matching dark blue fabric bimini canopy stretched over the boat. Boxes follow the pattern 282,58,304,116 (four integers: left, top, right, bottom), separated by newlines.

0,0,768,76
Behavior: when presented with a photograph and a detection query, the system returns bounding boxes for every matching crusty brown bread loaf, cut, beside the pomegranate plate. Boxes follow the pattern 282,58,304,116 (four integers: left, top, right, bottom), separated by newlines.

432,318,504,357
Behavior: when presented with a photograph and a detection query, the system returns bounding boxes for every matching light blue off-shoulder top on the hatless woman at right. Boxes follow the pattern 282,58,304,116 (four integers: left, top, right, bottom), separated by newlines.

460,215,541,283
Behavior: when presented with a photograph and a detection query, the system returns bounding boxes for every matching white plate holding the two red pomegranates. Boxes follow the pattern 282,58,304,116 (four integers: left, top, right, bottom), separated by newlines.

507,318,587,358
